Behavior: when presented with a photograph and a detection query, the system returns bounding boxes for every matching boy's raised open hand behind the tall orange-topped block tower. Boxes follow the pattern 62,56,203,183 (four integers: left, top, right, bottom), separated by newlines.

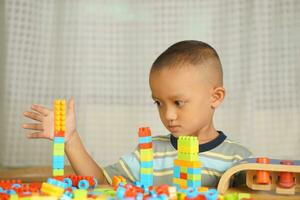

22,98,76,142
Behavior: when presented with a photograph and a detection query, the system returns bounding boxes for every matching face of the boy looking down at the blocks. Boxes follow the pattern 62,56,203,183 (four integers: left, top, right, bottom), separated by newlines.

150,66,214,137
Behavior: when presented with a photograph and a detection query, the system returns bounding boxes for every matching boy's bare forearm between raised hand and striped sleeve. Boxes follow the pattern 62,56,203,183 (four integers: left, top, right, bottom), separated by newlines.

65,131,108,184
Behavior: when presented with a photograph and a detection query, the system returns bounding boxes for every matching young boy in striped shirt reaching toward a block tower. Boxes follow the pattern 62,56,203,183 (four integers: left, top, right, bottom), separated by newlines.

23,41,251,187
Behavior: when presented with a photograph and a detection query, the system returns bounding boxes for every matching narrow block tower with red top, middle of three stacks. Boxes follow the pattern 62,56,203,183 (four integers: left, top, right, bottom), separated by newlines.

138,127,153,188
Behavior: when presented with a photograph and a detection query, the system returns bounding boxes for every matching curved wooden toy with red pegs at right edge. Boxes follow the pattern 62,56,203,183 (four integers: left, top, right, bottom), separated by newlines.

218,158,300,195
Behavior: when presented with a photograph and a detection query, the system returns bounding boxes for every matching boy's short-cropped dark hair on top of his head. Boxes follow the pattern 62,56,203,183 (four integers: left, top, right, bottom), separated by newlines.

151,40,223,84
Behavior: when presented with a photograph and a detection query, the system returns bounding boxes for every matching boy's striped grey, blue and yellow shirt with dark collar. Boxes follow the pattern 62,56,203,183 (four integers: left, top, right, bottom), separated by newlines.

103,131,251,187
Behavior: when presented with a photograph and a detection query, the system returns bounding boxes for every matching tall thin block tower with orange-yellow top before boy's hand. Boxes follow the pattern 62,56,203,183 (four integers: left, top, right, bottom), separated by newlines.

52,100,66,176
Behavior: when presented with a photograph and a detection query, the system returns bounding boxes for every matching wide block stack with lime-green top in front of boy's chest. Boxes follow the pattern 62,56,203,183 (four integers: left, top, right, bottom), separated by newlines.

173,136,202,189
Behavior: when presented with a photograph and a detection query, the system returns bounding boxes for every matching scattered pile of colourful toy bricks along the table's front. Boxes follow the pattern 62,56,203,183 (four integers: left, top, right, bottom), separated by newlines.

0,175,250,200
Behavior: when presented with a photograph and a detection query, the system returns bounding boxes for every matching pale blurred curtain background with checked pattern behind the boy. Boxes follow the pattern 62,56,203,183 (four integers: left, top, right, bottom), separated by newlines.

0,0,300,167
